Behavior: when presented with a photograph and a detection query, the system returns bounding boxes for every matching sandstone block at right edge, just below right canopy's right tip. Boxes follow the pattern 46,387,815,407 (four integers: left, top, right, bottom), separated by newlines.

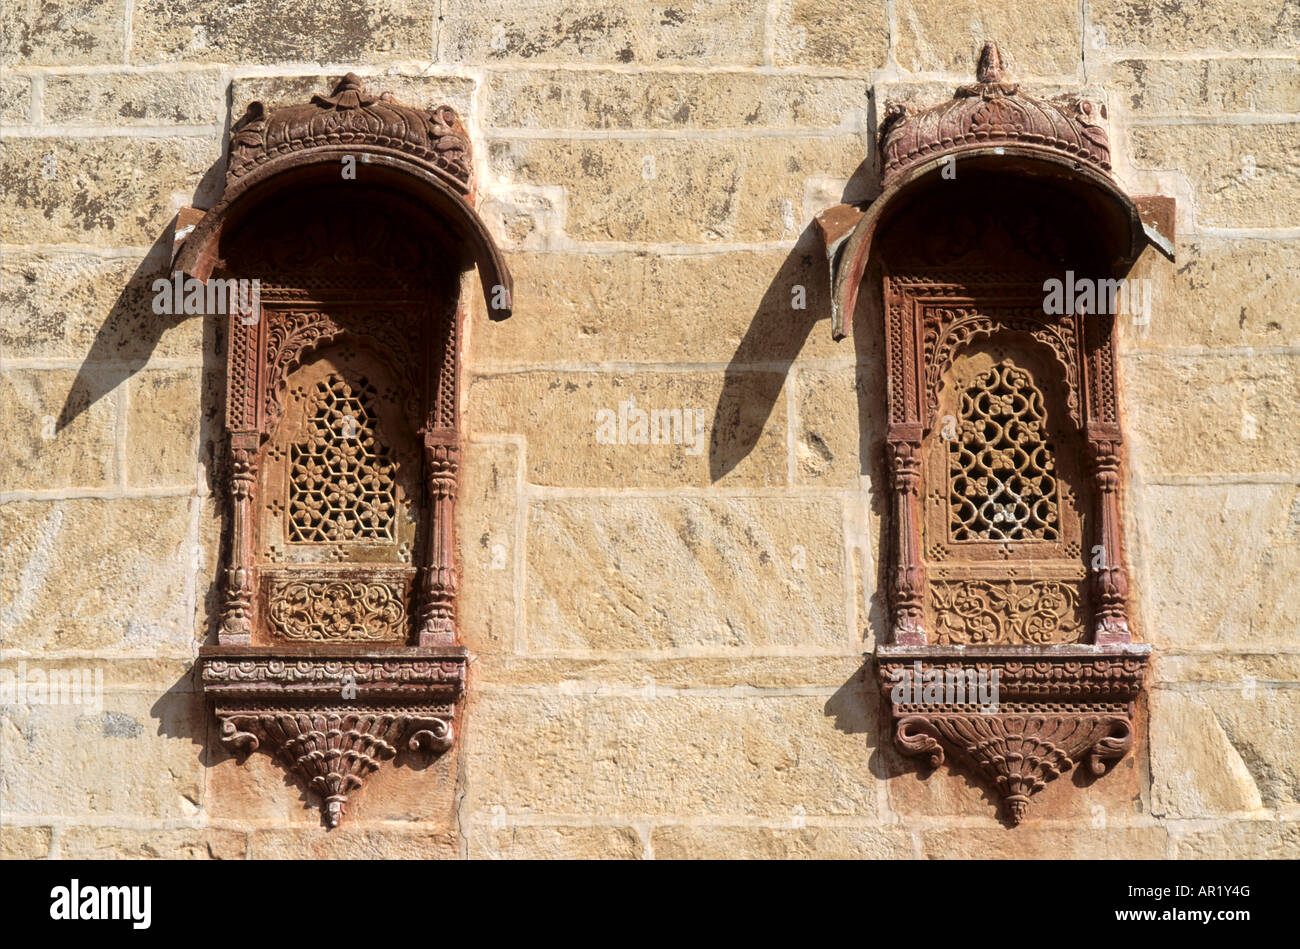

1118,238,1300,352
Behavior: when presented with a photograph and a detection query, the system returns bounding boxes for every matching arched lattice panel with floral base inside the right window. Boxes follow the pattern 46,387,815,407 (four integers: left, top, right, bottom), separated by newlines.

920,343,1091,646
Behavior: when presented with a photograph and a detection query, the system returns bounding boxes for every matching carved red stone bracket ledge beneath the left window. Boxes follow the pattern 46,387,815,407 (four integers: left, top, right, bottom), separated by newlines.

199,646,467,827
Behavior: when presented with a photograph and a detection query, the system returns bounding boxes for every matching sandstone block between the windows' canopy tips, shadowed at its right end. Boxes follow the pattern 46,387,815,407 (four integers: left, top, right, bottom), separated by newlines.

471,248,854,365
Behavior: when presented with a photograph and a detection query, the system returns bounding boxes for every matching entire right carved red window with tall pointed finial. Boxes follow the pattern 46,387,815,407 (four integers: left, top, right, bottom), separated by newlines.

818,44,1174,824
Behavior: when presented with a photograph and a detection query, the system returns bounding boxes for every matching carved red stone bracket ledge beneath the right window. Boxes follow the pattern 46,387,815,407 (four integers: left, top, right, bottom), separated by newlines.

876,645,1151,826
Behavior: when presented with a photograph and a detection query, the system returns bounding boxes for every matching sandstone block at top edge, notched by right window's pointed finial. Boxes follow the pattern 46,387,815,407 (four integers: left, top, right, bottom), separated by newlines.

894,0,1083,79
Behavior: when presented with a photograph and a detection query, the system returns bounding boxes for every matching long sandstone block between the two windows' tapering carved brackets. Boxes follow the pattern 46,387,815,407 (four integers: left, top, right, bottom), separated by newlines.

464,689,878,820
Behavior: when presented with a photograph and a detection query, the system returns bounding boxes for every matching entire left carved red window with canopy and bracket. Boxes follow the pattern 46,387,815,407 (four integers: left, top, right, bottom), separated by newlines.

176,75,511,827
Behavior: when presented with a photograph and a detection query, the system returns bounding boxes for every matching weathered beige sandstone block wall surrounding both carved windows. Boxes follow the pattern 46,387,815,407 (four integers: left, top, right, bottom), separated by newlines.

0,0,1300,858
